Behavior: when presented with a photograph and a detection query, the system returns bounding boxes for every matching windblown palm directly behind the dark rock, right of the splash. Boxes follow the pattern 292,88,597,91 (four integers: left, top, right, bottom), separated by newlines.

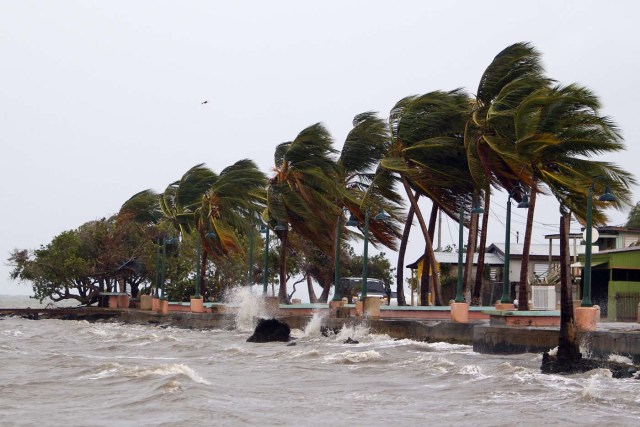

265,123,339,303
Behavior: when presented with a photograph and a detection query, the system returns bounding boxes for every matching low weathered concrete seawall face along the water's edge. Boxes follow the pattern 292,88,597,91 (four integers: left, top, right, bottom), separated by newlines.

5,308,640,363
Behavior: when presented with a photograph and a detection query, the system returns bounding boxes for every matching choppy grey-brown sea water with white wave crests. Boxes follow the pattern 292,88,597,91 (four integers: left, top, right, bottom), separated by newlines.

0,292,640,426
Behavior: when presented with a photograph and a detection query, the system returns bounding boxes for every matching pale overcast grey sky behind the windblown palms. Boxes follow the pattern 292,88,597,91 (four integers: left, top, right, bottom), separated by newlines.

0,0,640,294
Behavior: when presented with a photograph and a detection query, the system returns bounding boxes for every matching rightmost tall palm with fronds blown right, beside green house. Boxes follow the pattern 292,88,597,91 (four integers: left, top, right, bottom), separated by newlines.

502,85,634,310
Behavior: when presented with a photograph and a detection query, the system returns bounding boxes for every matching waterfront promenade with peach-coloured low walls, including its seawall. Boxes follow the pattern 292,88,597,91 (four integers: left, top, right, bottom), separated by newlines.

0,303,640,363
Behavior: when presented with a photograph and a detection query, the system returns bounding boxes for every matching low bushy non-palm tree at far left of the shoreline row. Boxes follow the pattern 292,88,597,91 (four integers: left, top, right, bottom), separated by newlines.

9,217,159,305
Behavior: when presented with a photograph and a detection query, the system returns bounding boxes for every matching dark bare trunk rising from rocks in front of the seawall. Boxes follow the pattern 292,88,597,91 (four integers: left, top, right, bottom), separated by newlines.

557,208,582,366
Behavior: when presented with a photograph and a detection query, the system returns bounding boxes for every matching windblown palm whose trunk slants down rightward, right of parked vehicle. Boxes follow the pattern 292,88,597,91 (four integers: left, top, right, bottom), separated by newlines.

381,89,474,304
